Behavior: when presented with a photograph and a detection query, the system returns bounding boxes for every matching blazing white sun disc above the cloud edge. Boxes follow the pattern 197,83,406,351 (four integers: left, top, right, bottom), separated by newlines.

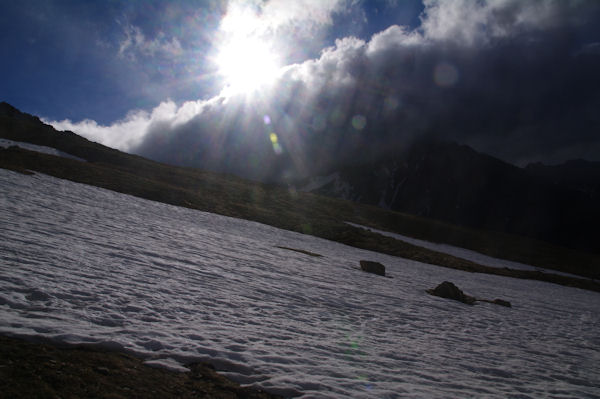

216,36,280,92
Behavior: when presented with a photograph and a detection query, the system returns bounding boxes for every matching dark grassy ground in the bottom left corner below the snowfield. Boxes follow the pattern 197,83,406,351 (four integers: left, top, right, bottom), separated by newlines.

0,336,279,399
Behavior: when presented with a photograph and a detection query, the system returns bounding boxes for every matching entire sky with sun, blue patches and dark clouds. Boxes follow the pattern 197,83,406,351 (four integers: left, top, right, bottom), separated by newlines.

0,0,600,180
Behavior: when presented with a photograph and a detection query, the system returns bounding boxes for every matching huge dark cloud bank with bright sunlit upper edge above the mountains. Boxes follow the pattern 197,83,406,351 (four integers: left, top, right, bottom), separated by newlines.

50,0,600,181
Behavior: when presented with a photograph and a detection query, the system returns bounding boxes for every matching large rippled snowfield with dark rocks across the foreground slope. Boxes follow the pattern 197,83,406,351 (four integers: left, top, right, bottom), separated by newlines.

0,170,600,398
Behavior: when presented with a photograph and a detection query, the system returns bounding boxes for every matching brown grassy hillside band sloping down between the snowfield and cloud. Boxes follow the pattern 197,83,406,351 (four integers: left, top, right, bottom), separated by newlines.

0,103,600,289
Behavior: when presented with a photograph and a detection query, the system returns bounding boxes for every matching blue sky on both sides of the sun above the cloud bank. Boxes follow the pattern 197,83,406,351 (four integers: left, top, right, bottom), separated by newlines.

0,0,422,124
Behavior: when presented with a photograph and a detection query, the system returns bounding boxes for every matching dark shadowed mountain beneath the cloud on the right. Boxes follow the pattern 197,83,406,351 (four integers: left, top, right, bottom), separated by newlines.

306,140,600,251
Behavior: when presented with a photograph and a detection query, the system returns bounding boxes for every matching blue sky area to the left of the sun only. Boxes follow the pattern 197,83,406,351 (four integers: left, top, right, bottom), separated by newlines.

0,0,222,123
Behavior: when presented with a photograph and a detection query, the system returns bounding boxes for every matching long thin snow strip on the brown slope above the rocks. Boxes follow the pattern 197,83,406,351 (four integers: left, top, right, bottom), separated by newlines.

346,222,585,278
